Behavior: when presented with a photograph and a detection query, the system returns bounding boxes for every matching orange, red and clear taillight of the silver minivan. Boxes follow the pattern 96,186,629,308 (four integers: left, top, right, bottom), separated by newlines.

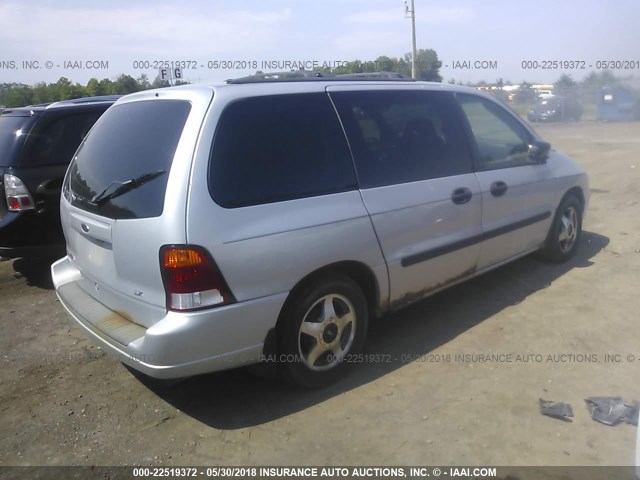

160,245,235,311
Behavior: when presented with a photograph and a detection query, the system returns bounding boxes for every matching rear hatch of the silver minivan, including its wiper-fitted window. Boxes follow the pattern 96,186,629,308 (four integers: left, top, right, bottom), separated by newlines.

61,87,213,327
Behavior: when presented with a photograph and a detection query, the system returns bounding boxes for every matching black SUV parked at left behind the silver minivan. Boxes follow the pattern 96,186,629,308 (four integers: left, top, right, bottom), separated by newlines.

0,95,120,258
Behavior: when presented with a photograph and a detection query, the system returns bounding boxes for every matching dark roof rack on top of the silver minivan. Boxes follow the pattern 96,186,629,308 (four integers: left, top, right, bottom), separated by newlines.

225,70,414,84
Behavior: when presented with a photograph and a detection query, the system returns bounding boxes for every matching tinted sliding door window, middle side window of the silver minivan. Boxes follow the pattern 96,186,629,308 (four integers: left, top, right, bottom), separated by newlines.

331,90,472,188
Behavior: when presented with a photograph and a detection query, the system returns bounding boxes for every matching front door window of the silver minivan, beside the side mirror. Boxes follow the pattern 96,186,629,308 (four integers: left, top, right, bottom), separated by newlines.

456,94,532,170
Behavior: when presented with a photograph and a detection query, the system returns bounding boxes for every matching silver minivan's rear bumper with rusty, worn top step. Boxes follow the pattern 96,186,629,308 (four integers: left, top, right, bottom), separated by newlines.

51,257,287,379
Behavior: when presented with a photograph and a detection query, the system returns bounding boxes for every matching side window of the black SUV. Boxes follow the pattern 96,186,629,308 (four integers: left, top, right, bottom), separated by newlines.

22,110,103,166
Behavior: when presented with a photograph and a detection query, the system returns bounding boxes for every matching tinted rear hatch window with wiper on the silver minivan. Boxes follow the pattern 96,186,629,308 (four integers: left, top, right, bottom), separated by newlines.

64,100,191,219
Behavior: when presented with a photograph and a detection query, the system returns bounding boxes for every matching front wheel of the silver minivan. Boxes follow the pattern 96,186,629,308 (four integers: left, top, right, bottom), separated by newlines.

540,194,584,263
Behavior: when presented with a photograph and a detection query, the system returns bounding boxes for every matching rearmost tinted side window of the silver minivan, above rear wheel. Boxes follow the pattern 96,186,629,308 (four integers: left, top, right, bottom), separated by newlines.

209,93,357,208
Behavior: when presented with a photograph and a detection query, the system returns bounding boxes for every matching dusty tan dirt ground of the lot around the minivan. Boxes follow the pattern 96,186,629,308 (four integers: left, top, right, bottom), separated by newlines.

0,122,640,465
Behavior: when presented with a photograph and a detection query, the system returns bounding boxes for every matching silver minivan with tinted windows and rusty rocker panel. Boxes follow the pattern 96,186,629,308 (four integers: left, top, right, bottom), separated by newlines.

51,77,589,387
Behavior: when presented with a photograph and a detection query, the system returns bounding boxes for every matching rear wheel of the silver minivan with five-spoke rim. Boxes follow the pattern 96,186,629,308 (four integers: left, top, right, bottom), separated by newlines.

278,275,368,388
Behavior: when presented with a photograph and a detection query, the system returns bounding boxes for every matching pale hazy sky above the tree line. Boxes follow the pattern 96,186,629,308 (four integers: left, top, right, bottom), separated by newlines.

0,0,640,84
